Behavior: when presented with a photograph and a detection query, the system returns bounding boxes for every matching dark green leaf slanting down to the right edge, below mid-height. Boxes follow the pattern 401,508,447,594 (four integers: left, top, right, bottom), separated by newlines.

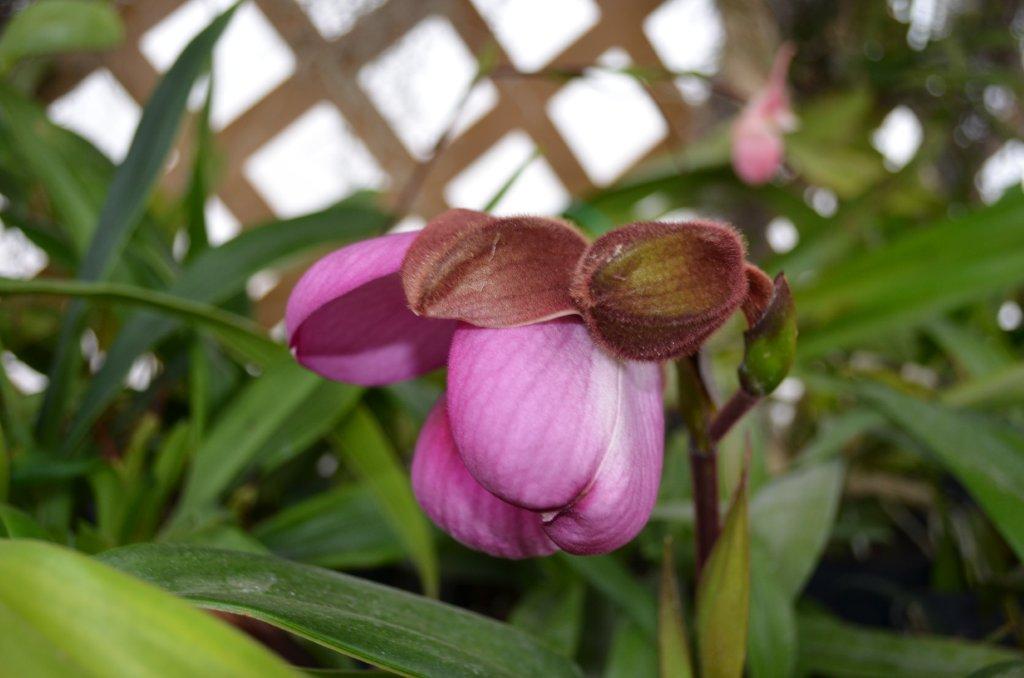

857,383,1024,560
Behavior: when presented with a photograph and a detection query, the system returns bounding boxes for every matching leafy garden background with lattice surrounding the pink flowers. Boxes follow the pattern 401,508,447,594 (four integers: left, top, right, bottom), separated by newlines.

0,0,1024,676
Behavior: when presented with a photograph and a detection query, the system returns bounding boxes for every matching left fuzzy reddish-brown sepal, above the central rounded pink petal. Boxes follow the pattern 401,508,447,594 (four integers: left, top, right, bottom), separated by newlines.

401,209,587,328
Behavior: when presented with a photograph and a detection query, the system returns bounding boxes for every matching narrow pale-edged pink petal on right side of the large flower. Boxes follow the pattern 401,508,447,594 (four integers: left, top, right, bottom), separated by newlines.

545,363,665,555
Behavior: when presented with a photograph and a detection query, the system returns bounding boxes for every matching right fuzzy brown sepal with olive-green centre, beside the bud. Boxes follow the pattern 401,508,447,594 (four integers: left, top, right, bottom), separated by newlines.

571,221,748,361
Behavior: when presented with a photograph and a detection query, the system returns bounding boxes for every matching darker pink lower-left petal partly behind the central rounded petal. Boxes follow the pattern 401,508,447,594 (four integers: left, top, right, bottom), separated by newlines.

413,397,557,558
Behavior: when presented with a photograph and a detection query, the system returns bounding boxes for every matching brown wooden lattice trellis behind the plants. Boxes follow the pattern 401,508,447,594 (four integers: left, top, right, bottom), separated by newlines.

43,0,712,325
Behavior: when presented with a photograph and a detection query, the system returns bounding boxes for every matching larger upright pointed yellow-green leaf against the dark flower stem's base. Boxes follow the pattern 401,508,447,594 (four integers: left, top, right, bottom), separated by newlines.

696,479,751,678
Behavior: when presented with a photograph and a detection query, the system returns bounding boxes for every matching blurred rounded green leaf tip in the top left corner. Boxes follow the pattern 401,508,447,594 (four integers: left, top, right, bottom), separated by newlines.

0,0,124,72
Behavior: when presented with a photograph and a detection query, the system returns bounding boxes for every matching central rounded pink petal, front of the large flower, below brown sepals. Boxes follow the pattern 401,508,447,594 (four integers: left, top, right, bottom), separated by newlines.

447,317,662,511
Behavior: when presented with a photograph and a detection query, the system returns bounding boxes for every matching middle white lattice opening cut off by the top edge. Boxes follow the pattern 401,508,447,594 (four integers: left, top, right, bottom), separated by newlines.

473,0,601,71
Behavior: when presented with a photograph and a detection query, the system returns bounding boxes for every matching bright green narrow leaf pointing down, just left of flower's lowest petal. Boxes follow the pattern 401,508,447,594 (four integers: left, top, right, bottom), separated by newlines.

332,406,440,597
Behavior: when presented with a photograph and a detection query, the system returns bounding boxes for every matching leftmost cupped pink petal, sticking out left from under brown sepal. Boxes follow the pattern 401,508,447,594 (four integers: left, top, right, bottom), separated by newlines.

285,232,456,386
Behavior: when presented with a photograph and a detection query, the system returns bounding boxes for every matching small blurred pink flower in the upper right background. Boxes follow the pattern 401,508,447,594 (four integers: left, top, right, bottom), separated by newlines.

732,44,797,185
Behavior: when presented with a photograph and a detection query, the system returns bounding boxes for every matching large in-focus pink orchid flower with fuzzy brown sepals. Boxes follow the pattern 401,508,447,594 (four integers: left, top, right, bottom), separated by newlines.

286,210,765,558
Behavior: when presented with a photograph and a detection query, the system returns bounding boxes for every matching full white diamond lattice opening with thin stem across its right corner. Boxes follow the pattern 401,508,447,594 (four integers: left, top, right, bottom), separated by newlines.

358,16,498,158
